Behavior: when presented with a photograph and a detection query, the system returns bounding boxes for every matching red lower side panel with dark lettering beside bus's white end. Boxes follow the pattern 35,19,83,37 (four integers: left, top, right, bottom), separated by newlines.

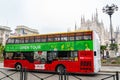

79,51,94,73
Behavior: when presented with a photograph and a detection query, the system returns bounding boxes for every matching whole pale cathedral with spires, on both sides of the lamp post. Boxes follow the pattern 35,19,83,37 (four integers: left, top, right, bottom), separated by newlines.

79,10,120,51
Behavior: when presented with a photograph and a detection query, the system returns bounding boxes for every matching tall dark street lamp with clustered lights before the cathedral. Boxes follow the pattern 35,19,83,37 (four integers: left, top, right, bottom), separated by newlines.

102,4,118,44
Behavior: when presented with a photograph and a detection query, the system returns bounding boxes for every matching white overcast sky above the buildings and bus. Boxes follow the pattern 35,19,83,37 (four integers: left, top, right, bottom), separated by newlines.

0,0,120,33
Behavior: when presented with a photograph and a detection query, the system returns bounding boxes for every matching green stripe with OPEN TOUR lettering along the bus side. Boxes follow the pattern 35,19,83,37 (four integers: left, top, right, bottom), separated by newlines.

5,40,93,51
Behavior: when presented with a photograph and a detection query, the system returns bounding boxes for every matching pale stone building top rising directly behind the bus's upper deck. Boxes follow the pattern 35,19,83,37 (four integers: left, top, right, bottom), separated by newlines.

15,25,39,35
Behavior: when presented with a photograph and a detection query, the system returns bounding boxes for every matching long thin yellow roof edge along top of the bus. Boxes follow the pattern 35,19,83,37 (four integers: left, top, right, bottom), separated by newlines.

10,30,92,38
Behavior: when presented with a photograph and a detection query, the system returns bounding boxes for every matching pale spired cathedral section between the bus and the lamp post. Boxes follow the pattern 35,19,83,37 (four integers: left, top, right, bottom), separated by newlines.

79,10,110,45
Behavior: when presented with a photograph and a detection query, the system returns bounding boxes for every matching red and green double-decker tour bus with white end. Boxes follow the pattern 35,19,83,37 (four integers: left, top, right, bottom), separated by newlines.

4,30,101,74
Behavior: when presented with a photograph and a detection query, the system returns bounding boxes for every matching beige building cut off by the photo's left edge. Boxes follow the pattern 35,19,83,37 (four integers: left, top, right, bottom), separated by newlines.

0,26,12,45
